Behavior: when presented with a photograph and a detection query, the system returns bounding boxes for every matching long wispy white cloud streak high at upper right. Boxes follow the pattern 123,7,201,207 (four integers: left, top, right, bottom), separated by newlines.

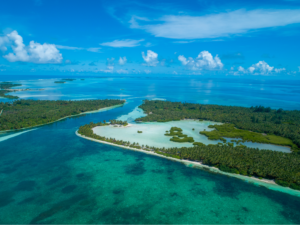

130,9,300,39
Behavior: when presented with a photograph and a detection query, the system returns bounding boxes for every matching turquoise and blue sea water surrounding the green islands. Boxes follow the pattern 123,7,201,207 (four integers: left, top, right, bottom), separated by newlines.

0,78,300,225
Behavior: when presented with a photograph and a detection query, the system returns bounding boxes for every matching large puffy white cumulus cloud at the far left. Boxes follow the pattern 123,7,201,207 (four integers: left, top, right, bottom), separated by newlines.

0,31,62,63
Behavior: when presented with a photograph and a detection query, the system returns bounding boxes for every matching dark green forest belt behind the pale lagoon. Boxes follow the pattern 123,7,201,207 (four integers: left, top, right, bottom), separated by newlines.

136,100,300,151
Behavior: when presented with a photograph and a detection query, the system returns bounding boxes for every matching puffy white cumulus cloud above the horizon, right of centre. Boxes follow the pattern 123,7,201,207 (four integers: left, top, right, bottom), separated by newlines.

178,51,223,70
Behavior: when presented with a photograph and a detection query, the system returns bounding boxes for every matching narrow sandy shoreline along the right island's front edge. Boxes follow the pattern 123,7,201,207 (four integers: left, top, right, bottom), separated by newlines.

75,130,300,197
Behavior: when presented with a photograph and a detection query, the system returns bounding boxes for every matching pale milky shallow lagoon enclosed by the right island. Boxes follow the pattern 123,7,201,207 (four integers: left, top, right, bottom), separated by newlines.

93,108,291,152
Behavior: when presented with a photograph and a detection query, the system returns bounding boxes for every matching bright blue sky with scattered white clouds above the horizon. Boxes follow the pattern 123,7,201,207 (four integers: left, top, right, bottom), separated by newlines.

0,0,300,76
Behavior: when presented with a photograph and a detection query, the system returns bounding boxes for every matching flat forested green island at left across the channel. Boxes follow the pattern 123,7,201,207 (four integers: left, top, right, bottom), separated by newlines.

0,100,127,131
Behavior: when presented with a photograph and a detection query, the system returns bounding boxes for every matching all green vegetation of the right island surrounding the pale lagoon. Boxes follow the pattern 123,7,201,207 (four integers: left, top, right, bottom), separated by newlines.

78,100,300,190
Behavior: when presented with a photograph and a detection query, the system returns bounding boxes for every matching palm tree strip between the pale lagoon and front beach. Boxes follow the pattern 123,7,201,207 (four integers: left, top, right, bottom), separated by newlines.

78,122,300,190
